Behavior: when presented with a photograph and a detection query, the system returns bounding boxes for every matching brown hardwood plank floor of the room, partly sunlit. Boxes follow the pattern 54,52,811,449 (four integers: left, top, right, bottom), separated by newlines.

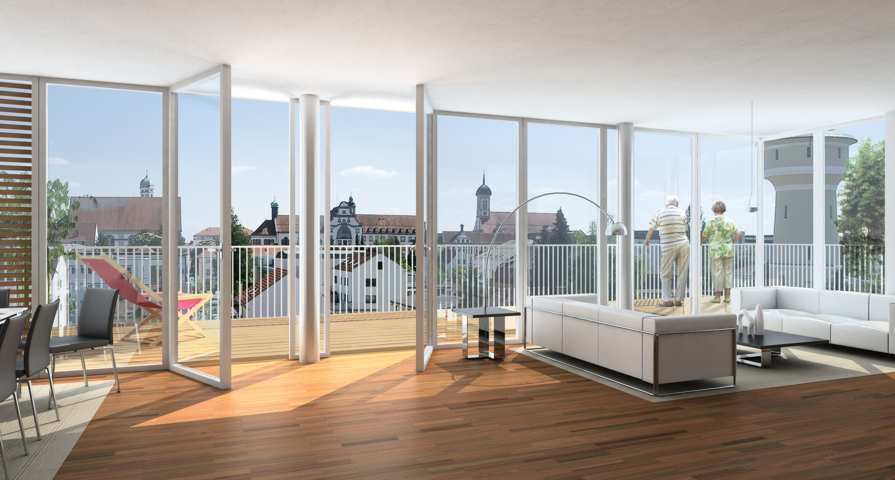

58,351,895,480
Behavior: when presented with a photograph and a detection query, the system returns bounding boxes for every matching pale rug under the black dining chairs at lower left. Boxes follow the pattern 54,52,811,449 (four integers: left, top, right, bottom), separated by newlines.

0,380,114,480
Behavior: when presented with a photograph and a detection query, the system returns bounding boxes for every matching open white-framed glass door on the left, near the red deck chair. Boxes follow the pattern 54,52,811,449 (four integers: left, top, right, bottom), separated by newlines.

168,65,233,388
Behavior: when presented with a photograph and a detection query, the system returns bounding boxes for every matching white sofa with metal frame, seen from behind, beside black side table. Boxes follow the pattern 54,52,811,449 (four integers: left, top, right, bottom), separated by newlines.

526,295,736,394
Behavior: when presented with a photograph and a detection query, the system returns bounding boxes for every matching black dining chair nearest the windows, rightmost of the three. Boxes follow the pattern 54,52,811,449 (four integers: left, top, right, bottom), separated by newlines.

50,288,121,393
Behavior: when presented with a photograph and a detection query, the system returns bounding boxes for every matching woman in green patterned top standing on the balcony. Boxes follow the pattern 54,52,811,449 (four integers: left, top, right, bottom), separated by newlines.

702,200,742,303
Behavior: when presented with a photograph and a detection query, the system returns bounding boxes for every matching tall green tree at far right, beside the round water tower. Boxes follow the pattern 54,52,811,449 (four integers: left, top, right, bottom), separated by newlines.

836,139,886,288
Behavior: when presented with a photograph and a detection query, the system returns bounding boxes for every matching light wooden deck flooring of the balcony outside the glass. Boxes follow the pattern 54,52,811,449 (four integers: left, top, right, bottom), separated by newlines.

50,297,730,372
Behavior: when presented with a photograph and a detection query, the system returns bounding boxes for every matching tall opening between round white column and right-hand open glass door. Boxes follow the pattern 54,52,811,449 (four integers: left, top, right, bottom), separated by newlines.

323,106,417,352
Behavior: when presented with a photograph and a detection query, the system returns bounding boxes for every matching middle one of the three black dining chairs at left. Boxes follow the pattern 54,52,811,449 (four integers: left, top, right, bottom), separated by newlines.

16,300,59,440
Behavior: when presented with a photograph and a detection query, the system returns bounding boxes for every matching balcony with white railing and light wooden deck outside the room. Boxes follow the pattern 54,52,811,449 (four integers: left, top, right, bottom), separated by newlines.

51,244,883,370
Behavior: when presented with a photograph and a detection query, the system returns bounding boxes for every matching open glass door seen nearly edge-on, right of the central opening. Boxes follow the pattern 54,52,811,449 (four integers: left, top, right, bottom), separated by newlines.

412,85,438,372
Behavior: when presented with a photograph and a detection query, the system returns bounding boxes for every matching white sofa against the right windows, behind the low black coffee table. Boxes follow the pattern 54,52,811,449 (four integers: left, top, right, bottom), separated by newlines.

731,287,895,354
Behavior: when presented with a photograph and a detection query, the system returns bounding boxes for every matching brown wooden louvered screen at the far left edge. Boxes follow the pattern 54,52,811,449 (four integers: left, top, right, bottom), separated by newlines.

0,78,34,307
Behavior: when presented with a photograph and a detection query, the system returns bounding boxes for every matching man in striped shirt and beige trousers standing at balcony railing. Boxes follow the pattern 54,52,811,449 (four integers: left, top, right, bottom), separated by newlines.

643,195,690,307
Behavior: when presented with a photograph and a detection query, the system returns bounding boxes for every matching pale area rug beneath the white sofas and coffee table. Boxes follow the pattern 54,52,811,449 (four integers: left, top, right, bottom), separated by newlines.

517,345,895,402
